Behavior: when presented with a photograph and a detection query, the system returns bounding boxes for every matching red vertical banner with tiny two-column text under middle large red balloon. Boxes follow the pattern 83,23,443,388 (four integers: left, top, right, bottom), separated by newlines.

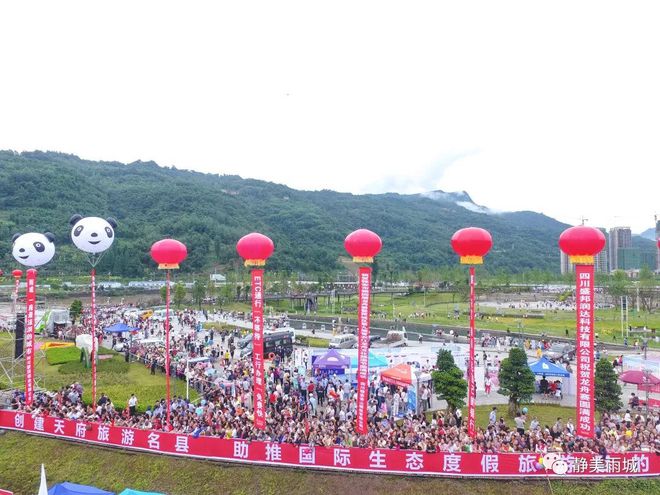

357,266,371,435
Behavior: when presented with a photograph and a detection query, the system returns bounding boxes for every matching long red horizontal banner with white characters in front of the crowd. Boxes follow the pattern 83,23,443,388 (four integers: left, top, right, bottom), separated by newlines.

0,410,660,478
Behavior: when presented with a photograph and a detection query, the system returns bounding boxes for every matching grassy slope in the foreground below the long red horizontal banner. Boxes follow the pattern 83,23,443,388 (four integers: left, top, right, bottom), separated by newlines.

0,432,660,495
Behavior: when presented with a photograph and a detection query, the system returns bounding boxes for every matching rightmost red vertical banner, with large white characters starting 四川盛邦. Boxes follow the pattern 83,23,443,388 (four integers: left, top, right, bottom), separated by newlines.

575,265,595,438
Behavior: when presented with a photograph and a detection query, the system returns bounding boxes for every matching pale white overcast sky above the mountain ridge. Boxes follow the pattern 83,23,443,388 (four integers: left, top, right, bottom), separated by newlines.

0,0,660,232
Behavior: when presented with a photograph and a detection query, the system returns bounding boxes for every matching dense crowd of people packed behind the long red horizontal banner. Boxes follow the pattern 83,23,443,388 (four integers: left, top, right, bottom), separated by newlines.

3,302,660,453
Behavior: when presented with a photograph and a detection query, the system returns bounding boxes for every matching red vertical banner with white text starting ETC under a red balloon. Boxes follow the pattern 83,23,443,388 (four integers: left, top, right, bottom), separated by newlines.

251,268,266,430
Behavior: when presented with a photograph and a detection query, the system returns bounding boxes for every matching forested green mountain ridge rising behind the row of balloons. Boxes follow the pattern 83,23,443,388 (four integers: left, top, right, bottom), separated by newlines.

0,151,567,276
